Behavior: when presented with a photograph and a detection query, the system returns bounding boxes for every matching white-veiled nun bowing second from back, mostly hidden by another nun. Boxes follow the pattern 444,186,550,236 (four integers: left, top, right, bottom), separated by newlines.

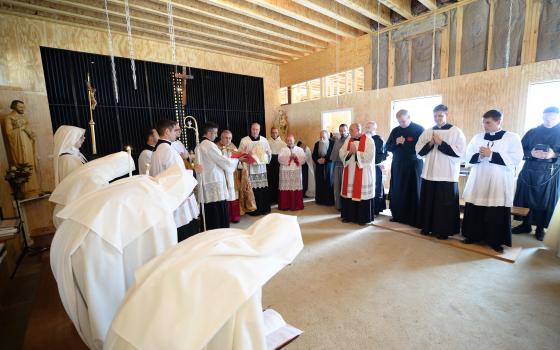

49,152,135,228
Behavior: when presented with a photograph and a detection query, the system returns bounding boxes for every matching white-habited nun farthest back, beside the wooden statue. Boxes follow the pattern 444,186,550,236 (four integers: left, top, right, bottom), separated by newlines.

53,125,87,186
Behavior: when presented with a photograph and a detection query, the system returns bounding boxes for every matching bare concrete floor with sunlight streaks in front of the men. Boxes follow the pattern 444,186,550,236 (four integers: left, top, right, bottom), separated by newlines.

240,203,560,350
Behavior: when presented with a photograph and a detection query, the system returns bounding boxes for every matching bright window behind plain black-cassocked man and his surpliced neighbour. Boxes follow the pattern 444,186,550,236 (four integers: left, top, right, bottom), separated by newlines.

391,96,442,130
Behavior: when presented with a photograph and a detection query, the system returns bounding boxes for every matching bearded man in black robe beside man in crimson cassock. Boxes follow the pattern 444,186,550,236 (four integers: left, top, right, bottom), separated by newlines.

311,130,334,205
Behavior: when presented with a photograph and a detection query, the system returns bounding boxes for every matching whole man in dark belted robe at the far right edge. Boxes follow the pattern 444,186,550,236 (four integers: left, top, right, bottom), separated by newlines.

512,107,560,241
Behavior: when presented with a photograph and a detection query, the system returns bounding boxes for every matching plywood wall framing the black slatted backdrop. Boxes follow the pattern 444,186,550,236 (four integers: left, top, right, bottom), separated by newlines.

0,13,280,197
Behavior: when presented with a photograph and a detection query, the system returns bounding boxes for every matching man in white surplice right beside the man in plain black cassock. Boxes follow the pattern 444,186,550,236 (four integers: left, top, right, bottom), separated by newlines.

416,105,467,239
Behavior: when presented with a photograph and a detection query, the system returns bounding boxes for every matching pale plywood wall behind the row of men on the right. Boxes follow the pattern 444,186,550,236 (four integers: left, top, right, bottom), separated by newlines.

282,60,560,152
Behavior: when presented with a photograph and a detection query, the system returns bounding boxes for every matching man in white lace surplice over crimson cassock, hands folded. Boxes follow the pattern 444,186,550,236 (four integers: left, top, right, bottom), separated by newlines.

278,135,306,210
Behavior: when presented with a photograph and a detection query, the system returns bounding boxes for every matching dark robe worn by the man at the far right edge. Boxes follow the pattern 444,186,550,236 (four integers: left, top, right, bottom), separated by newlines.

513,124,560,228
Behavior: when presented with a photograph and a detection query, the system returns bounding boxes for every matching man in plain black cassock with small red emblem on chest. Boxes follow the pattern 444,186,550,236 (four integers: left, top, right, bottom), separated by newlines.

385,109,424,226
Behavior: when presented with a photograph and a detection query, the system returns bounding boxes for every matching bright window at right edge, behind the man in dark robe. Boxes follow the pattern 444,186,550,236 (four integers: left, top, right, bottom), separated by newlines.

525,81,560,132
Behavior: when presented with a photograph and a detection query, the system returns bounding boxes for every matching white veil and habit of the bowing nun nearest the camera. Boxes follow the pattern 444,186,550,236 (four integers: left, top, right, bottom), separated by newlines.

106,214,303,350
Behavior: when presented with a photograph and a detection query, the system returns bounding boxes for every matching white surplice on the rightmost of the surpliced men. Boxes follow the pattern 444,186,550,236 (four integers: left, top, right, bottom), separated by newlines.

463,132,523,208
